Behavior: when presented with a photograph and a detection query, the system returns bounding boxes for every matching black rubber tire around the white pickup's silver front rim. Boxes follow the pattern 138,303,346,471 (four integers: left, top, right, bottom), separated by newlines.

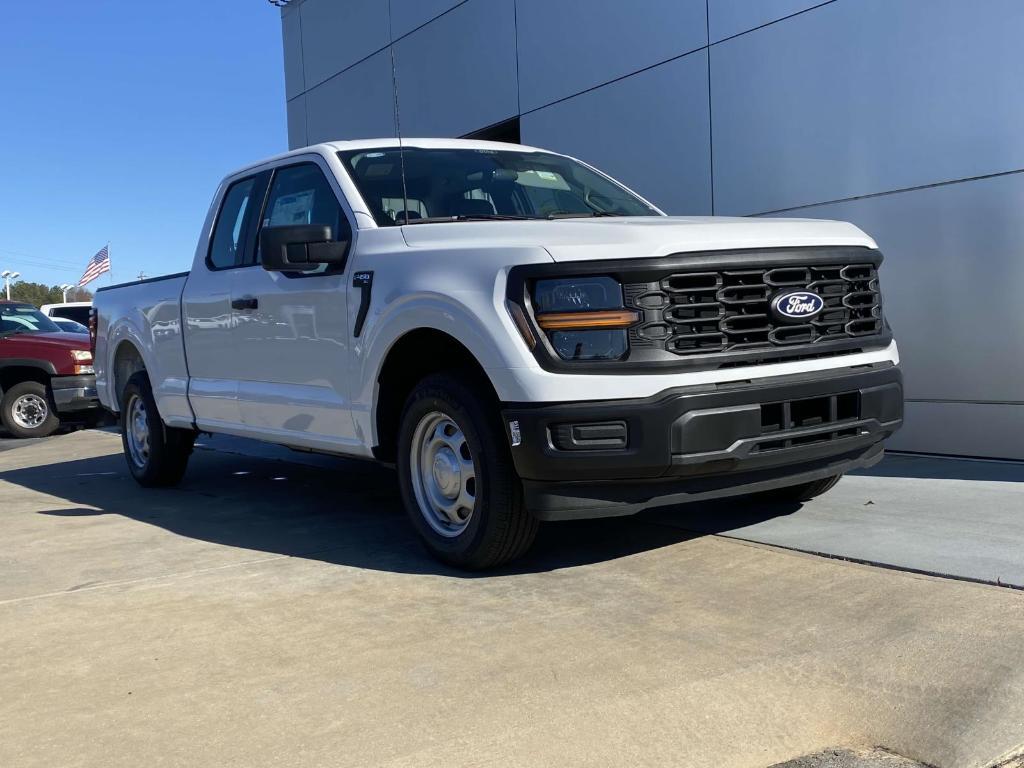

397,372,540,570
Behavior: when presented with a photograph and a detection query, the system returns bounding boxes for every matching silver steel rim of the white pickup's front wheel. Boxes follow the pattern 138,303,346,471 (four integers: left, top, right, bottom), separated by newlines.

409,411,479,539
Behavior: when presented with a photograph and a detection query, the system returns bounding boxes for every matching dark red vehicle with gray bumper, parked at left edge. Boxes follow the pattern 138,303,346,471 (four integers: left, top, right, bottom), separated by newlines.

0,301,101,437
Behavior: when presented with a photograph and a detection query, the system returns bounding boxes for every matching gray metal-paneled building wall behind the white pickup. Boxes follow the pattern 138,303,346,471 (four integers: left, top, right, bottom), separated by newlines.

282,0,1024,459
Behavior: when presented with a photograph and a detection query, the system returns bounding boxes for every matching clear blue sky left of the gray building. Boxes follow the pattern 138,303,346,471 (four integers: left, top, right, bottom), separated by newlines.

0,0,288,288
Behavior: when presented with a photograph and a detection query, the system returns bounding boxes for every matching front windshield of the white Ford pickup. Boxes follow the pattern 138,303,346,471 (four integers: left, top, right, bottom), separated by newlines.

338,146,660,226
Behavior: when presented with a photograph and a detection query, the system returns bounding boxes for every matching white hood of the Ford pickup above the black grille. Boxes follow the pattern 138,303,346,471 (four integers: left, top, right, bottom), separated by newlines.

402,216,877,261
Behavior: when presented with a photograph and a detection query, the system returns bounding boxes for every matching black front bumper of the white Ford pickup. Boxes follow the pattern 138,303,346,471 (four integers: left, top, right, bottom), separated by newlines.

503,364,903,519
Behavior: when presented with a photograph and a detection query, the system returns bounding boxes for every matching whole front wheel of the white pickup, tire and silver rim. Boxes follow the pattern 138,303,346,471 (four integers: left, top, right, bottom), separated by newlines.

398,374,539,569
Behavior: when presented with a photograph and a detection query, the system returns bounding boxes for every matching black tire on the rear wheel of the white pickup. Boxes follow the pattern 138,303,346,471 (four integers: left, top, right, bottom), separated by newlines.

121,371,196,487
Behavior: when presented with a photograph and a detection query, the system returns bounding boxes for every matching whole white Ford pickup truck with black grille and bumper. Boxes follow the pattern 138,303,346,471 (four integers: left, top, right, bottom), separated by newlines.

93,139,903,568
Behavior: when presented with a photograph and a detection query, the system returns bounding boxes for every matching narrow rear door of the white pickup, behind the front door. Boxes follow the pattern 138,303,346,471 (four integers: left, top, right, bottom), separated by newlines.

181,172,270,431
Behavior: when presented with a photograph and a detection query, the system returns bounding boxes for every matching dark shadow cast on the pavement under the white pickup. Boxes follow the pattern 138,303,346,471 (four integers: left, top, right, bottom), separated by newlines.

0,436,797,578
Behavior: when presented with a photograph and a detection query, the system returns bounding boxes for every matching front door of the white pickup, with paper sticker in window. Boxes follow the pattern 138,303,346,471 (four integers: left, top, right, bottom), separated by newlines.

231,158,361,453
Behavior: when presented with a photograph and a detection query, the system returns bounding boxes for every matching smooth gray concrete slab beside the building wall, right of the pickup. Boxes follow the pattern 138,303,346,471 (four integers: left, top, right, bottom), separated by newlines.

654,455,1024,589
